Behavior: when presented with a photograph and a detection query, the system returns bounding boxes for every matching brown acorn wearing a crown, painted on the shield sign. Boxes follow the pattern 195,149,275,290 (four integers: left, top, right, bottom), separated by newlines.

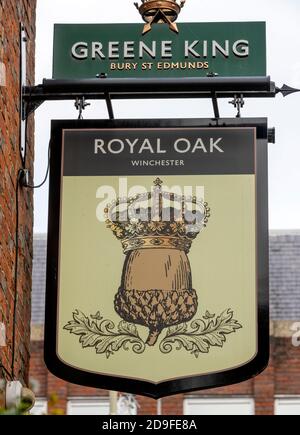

105,178,210,346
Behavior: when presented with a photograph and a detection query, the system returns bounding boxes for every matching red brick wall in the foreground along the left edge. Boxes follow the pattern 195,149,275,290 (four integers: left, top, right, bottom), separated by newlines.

0,0,36,383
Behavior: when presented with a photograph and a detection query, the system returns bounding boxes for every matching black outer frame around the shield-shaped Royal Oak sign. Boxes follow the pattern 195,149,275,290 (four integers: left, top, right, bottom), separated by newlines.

44,118,269,399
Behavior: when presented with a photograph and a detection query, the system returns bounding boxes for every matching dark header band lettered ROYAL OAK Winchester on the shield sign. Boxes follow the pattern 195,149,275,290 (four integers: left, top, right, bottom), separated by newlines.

63,128,256,176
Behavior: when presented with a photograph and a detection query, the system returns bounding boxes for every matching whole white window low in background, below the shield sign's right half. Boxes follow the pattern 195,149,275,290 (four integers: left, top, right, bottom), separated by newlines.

183,397,254,415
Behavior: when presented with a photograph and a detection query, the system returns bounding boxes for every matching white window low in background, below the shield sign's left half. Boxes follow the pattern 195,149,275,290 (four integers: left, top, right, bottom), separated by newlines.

67,397,109,415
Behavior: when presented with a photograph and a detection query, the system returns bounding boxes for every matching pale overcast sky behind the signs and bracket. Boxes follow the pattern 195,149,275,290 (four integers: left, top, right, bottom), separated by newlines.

34,0,300,232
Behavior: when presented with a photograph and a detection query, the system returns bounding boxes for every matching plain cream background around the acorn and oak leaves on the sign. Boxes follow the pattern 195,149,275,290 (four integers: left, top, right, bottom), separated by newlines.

58,175,257,382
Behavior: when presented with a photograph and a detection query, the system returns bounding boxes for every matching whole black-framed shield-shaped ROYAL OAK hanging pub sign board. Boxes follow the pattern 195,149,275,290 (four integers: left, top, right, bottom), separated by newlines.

45,119,268,398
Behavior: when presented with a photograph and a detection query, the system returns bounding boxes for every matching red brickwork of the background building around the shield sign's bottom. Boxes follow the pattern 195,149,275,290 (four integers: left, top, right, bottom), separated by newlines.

30,338,300,415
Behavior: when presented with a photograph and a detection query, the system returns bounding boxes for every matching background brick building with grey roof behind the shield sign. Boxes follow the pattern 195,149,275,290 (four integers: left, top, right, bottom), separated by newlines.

30,232,300,415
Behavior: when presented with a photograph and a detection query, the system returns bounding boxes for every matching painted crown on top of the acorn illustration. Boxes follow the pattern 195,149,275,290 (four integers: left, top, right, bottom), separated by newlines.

105,178,210,253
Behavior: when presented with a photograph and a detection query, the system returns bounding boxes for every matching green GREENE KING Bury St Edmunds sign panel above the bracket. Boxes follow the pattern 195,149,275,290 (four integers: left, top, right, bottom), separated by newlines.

53,22,266,79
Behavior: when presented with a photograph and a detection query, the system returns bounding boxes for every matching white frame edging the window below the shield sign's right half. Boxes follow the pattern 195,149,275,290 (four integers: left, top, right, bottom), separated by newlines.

183,396,255,415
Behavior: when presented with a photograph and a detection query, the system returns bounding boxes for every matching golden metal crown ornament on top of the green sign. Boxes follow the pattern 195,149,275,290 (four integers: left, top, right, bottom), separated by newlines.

134,0,186,35
